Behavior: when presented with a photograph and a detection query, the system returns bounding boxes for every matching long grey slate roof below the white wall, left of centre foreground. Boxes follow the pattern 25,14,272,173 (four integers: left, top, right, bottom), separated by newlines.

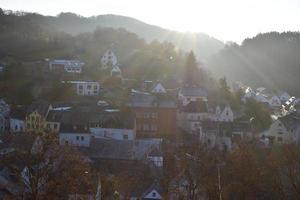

87,138,161,160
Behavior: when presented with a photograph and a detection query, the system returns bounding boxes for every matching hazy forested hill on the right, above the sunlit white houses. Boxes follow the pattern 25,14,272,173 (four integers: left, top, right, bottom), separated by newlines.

207,32,300,95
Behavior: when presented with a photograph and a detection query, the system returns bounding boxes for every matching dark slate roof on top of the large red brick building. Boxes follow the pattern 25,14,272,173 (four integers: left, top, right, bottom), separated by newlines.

129,93,176,108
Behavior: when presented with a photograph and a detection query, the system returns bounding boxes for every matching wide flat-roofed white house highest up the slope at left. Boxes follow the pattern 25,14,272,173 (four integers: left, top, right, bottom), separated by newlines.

49,60,85,73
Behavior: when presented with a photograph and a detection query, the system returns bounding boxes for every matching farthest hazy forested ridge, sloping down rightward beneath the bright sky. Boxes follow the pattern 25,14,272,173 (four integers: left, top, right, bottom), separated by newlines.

0,9,224,60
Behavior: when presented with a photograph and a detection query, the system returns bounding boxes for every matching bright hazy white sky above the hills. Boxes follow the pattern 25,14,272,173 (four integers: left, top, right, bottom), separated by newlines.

0,0,300,42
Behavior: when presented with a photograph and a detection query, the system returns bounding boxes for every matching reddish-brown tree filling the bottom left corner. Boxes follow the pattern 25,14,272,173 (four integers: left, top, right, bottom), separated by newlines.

1,136,92,200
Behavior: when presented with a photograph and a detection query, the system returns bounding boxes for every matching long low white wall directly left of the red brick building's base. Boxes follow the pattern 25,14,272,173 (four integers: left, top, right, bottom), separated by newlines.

90,128,135,140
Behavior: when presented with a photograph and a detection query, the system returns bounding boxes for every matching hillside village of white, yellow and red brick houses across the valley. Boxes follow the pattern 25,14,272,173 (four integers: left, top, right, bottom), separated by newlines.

0,49,300,200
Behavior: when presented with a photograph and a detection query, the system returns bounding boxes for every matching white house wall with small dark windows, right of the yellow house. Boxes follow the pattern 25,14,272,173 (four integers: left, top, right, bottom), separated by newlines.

59,133,91,147
